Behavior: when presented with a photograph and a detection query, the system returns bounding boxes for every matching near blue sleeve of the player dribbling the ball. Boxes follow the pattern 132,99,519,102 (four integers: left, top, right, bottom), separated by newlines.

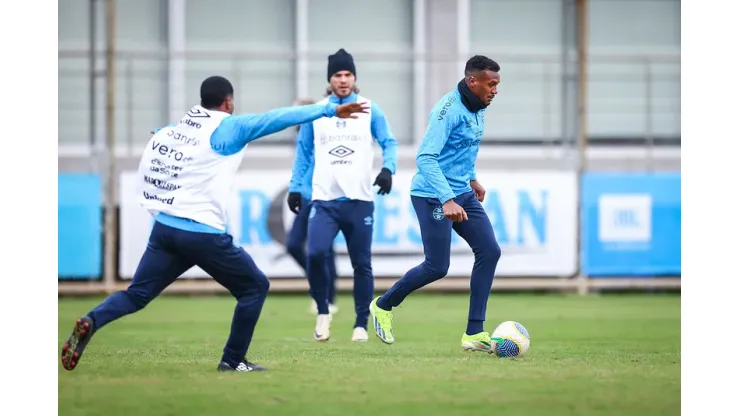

416,107,457,204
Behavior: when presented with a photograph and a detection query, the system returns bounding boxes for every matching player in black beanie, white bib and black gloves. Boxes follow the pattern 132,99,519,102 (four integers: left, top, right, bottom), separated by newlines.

290,49,398,342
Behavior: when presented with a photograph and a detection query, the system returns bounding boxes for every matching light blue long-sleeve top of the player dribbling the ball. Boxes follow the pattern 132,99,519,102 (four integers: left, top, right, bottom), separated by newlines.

410,88,486,204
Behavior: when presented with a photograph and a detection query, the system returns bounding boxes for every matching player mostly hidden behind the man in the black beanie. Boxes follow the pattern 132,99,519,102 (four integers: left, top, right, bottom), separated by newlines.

285,99,339,314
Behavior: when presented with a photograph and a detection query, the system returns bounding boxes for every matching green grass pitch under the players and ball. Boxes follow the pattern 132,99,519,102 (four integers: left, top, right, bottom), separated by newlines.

57,293,681,416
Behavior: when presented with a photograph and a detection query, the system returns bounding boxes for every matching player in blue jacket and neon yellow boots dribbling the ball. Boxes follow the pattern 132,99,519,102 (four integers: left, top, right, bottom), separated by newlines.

370,55,501,352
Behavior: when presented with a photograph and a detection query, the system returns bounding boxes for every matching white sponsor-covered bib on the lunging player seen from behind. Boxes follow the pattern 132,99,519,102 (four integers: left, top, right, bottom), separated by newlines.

137,105,244,230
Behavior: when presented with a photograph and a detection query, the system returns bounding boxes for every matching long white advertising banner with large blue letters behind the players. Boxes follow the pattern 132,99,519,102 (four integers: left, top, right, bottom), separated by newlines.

119,170,577,279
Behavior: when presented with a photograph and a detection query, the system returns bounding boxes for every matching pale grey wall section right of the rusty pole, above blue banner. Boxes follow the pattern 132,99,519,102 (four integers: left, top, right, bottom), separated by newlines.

588,0,681,137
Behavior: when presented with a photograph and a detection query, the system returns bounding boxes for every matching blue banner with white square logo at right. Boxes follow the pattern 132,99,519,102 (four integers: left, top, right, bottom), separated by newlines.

581,173,681,277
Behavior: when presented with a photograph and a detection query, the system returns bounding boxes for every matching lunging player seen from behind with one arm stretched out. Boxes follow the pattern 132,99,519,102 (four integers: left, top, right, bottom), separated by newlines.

61,76,369,372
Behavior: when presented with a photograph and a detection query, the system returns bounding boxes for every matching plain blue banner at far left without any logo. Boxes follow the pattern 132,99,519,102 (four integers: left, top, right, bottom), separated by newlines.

57,173,103,279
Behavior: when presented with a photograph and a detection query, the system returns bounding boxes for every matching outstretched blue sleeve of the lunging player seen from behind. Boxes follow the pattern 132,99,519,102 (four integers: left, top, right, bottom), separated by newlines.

211,103,337,156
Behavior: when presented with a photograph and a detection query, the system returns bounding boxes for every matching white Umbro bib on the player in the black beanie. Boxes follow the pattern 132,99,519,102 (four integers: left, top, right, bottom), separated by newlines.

312,96,375,201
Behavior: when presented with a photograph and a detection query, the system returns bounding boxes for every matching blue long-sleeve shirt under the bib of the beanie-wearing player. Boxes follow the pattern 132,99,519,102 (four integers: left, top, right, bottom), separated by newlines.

289,93,398,200
